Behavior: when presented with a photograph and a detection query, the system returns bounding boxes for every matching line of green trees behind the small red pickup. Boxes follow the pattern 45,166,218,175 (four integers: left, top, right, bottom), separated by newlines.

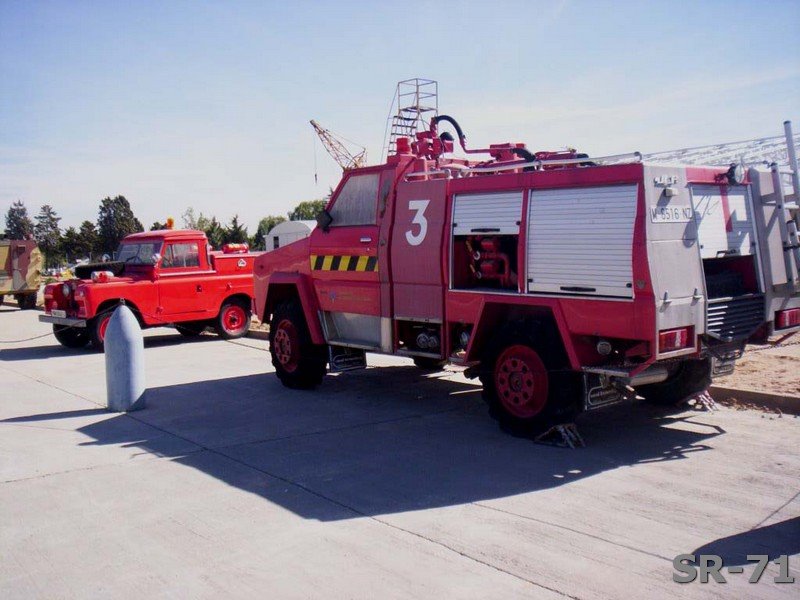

5,196,328,268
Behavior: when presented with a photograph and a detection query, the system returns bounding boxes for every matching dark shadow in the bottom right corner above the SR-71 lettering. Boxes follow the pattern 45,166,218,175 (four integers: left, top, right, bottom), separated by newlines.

693,517,800,566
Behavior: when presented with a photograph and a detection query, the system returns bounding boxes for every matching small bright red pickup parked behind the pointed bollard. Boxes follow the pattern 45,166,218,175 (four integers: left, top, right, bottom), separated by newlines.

39,229,256,350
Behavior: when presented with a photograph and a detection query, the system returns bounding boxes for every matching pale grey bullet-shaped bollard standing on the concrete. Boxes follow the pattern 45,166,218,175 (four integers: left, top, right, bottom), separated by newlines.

104,304,147,412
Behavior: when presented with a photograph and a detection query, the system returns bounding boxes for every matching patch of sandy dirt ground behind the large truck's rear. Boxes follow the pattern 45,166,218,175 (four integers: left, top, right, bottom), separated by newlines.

714,342,800,396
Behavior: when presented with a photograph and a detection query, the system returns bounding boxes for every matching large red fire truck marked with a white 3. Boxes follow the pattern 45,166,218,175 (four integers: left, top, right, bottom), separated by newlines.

254,116,800,432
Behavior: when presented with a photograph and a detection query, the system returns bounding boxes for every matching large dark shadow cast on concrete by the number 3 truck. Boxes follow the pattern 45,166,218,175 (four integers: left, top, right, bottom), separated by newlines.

4,366,724,521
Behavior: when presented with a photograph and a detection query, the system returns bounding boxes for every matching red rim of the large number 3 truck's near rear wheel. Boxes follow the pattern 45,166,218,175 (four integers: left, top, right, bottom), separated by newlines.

494,344,547,419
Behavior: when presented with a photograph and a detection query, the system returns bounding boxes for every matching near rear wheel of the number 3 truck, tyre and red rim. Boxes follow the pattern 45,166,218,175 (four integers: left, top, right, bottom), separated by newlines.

480,325,581,435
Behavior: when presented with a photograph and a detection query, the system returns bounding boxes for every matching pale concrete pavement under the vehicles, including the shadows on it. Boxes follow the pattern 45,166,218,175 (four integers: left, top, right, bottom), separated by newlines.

0,307,800,598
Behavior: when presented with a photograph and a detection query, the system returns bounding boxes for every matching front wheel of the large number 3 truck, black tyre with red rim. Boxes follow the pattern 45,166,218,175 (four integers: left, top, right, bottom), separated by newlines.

269,301,328,390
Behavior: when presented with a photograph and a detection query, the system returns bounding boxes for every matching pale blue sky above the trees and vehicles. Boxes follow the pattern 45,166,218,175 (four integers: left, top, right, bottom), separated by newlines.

0,0,800,231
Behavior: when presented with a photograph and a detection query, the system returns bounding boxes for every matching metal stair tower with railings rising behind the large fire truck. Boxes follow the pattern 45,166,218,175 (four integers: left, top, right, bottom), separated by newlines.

384,77,439,156
